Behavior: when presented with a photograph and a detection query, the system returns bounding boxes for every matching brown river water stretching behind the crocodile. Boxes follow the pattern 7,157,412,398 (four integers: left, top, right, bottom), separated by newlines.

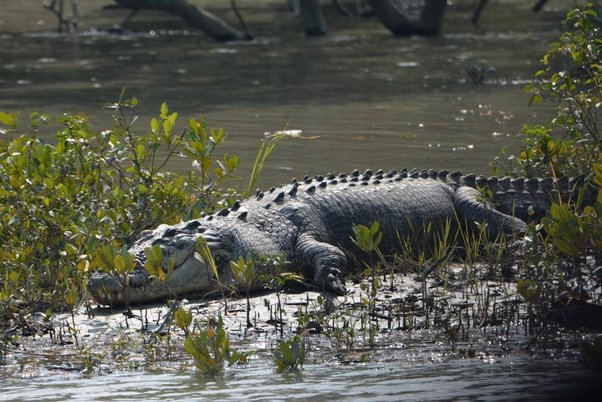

0,0,570,183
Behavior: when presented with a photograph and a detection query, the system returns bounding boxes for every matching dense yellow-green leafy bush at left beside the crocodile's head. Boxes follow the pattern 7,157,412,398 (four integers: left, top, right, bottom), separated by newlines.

0,99,238,307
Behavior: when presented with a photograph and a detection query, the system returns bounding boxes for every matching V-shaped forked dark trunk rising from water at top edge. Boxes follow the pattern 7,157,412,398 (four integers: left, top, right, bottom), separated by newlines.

369,0,447,36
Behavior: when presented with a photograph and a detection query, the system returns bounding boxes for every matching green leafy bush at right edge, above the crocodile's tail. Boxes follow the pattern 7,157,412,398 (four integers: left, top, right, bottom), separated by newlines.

493,1,602,176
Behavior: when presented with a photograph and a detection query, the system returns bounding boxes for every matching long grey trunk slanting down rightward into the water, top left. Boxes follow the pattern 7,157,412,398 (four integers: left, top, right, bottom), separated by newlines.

115,0,250,41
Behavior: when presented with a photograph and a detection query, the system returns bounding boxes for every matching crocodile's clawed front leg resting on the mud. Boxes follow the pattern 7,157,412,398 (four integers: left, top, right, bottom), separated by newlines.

295,234,347,296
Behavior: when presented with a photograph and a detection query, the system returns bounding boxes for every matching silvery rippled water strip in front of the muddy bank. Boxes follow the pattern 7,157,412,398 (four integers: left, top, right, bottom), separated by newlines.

0,356,599,401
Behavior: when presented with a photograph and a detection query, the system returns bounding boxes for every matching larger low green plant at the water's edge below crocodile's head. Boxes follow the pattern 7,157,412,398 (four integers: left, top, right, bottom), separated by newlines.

174,308,249,377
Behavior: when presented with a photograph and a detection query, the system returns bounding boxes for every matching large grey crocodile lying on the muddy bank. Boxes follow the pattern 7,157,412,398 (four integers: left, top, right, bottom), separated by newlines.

88,170,593,305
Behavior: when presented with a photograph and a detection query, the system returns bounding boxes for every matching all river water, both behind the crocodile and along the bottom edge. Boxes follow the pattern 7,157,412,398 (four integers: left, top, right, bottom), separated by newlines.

0,0,599,400
